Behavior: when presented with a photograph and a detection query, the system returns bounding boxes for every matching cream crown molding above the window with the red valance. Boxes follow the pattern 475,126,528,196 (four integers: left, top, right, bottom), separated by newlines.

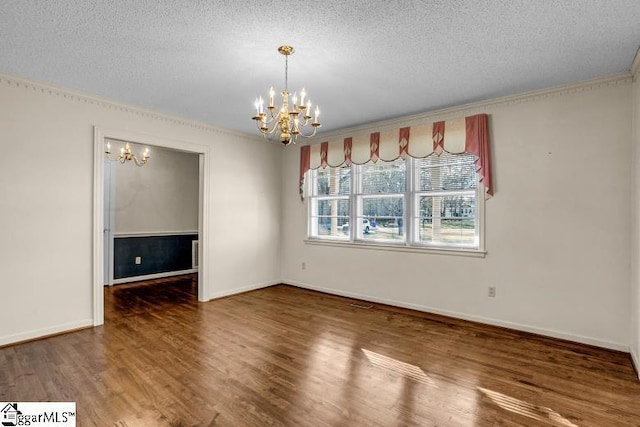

303,72,632,145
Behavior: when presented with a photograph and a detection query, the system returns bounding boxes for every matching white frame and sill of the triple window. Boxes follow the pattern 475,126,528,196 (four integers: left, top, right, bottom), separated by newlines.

305,157,486,257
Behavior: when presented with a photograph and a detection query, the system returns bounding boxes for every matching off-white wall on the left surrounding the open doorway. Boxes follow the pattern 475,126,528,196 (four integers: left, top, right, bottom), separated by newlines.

0,75,281,345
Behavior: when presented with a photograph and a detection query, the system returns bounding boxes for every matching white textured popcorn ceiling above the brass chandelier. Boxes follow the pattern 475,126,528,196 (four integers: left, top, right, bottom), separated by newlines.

0,0,640,137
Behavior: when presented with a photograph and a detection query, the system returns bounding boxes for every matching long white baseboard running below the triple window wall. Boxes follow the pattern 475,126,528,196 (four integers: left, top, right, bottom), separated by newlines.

282,280,637,352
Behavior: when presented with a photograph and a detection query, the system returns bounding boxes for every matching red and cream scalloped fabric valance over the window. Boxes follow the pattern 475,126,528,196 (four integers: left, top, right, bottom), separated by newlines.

300,114,493,201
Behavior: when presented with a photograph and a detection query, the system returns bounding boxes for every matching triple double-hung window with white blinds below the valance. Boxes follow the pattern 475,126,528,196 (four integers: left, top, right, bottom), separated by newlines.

309,152,484,250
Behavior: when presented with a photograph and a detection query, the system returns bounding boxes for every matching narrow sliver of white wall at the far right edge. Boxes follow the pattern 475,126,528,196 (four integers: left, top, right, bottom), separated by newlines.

631,54,640,376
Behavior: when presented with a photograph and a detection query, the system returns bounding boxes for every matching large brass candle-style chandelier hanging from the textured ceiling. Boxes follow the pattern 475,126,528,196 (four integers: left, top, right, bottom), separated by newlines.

253,45,321,145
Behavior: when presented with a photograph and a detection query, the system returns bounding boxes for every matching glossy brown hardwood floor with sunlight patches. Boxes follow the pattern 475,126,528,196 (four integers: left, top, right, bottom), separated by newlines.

0,276,640,427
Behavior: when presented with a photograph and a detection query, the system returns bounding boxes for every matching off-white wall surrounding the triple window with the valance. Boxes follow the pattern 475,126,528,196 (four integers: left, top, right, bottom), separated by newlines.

282,77,631,351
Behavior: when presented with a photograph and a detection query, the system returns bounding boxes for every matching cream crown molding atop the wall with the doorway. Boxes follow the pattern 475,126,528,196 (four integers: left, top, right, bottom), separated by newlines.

0,73,262,141
